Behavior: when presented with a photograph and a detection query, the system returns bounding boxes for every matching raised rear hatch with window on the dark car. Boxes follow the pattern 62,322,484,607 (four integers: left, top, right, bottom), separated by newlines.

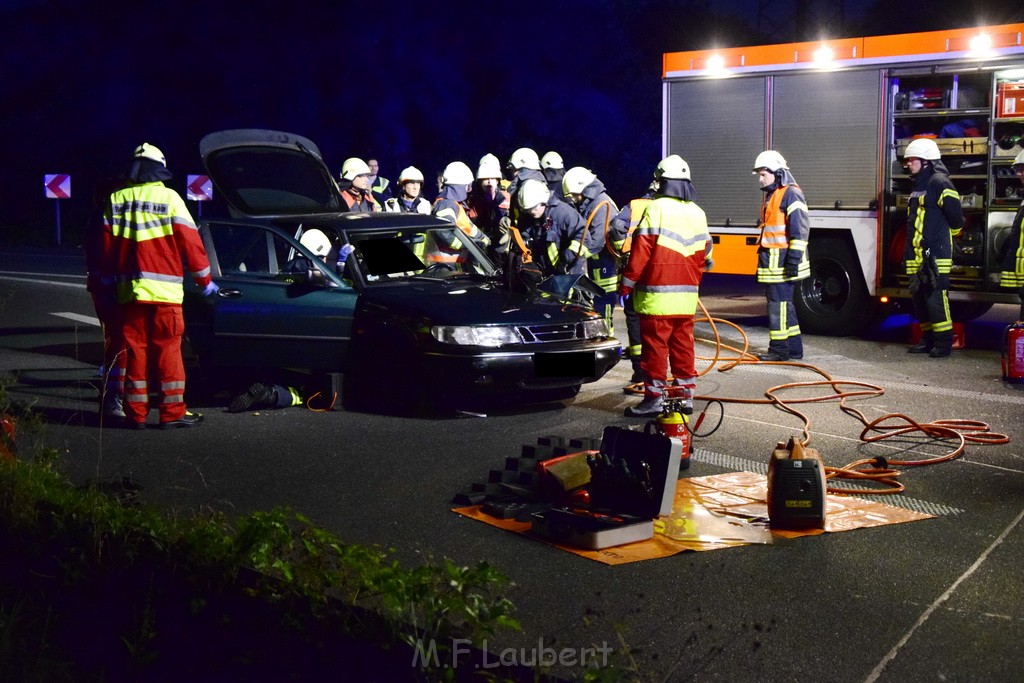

199,128,345,218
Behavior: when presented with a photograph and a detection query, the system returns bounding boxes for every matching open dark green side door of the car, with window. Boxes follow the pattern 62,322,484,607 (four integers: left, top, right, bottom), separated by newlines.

197,221,357,371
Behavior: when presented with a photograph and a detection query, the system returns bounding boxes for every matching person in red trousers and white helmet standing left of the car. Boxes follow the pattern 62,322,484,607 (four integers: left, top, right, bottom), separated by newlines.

103,142,219,429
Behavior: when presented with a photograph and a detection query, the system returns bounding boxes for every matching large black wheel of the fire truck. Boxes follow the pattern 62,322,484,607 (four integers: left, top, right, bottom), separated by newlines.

794,238,877,337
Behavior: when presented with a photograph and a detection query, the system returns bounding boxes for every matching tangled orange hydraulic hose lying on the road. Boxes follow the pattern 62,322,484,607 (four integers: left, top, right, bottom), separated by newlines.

694,300,1010,495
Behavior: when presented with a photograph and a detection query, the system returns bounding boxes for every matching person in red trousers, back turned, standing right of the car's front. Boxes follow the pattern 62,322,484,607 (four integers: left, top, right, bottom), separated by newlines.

618,155,712,417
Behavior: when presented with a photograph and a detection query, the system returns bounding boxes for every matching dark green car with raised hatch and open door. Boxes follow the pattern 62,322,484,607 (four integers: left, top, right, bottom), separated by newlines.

185,130,622,408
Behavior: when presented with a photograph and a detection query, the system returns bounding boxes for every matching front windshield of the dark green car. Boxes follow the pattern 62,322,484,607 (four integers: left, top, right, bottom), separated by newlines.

346,225,495,283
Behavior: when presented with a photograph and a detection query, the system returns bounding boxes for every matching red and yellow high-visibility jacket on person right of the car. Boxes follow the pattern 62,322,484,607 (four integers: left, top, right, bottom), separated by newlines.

620,197,712,315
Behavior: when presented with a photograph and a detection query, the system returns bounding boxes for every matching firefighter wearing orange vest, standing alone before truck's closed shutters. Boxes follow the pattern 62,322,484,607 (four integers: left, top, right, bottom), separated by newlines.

754,150,811,362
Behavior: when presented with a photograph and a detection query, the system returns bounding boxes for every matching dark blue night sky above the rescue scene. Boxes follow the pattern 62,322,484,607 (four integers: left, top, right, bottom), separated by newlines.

0,0,1024,247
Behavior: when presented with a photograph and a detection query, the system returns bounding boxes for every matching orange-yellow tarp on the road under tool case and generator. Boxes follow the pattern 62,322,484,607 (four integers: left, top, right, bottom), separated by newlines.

454,472,934,564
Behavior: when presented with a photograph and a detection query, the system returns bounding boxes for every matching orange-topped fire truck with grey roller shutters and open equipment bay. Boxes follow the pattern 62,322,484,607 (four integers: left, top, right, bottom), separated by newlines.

662,24,1024,335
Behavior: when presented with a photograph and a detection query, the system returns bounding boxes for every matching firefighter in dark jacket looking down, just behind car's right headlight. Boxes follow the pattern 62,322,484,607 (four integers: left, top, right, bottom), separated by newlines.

561,162,618,328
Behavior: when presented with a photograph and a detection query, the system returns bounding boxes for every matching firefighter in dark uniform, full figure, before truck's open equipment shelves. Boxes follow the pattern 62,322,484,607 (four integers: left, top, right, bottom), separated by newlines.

903,138,964,358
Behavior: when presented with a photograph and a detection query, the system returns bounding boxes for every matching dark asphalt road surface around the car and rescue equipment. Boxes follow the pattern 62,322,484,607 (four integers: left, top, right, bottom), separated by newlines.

0,249,1024,681
